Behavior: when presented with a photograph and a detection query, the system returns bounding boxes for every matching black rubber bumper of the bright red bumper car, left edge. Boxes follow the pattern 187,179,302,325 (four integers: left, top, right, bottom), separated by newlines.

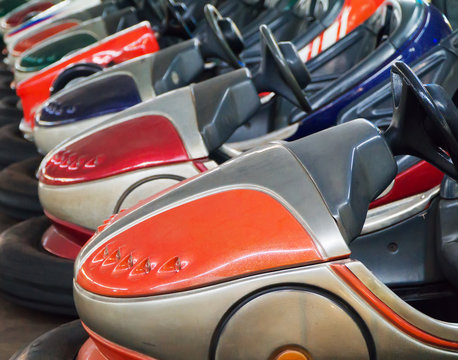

0,123,39,167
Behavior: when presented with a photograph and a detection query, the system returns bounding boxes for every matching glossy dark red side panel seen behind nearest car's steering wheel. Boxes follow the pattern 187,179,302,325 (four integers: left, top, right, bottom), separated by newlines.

370,161,444,208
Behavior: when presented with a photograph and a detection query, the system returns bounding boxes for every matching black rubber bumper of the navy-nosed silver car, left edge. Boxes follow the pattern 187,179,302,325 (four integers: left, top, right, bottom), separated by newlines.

0,156,43,220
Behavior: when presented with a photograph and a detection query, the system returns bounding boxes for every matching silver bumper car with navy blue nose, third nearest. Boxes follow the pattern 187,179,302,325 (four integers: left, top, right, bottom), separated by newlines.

32,0,354,154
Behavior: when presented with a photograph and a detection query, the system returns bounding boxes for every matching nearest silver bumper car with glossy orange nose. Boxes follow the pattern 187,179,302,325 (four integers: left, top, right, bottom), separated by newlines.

13,62,458,360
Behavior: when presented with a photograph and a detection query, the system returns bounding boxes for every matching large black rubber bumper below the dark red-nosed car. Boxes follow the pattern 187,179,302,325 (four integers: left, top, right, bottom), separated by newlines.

0,216,76,316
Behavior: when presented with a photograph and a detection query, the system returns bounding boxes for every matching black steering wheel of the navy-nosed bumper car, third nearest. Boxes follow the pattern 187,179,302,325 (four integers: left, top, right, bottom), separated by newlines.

204,4,244,69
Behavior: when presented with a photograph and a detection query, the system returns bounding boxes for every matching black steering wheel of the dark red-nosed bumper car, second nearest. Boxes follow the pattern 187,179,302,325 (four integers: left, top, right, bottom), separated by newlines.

259,25,312,112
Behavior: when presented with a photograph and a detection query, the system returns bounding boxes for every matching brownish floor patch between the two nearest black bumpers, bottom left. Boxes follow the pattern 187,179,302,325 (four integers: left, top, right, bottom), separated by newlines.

0,295,72,360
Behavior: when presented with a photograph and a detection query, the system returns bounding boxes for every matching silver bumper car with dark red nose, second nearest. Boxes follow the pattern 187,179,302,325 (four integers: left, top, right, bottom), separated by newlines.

0,3,448,316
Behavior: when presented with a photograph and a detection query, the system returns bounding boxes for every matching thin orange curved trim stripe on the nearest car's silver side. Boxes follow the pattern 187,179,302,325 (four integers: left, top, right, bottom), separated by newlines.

331,264,458,351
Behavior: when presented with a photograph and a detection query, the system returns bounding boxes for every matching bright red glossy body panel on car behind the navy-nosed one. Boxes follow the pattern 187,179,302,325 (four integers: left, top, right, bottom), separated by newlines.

16,23,159,128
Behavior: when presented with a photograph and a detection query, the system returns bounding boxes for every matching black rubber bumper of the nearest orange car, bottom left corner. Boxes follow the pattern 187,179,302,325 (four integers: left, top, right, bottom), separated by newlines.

10,320,88,360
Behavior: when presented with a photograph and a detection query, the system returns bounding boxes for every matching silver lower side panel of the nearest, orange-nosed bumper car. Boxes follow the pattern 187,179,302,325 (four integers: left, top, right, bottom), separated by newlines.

74,263,457,360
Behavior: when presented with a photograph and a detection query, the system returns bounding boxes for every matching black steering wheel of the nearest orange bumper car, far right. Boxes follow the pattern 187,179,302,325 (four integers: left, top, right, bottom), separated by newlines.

384,61,458,180
